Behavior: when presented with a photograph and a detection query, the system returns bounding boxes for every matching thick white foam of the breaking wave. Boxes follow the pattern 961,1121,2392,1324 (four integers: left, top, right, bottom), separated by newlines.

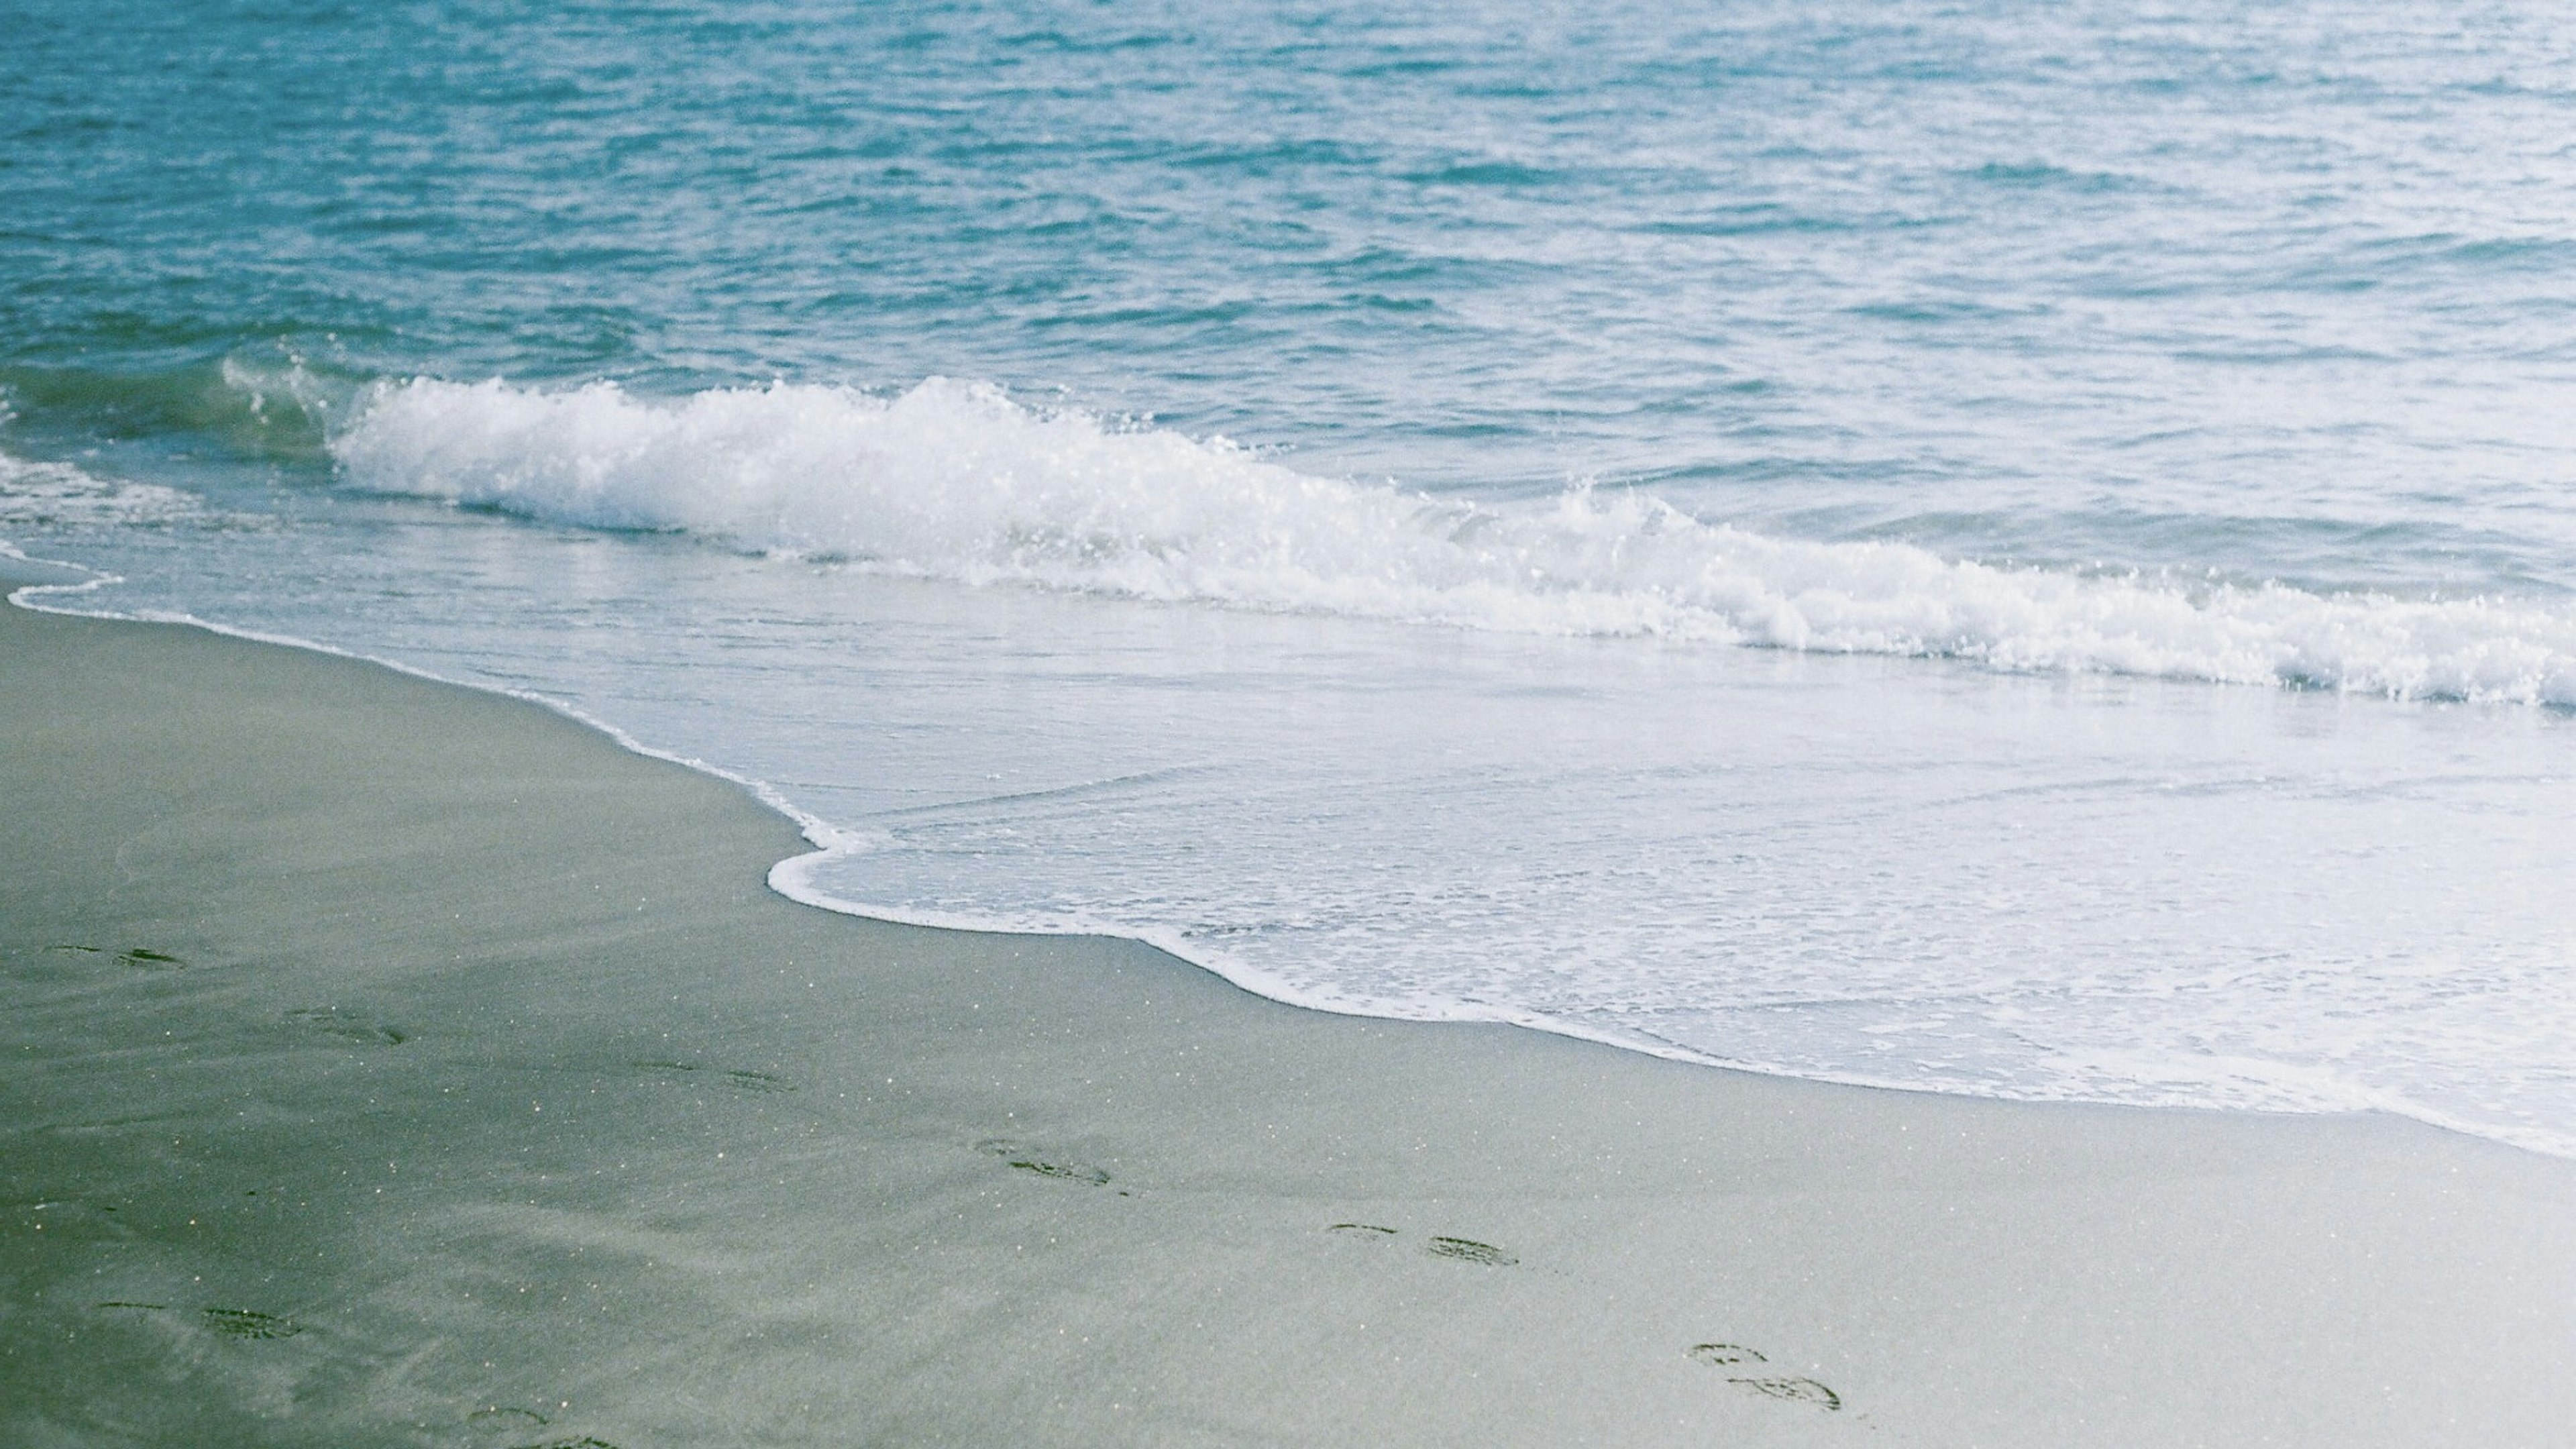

332,379,2576,704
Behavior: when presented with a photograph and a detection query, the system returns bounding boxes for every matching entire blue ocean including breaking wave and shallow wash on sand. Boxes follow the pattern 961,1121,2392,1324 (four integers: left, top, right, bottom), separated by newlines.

0,0,2576,1155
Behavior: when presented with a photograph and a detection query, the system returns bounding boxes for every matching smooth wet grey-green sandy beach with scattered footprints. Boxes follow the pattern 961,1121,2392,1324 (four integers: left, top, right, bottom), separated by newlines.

0,580,2576,1449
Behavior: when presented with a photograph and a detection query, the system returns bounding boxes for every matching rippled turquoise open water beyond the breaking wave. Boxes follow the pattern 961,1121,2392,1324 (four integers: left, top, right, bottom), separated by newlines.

15,5,2576,593
